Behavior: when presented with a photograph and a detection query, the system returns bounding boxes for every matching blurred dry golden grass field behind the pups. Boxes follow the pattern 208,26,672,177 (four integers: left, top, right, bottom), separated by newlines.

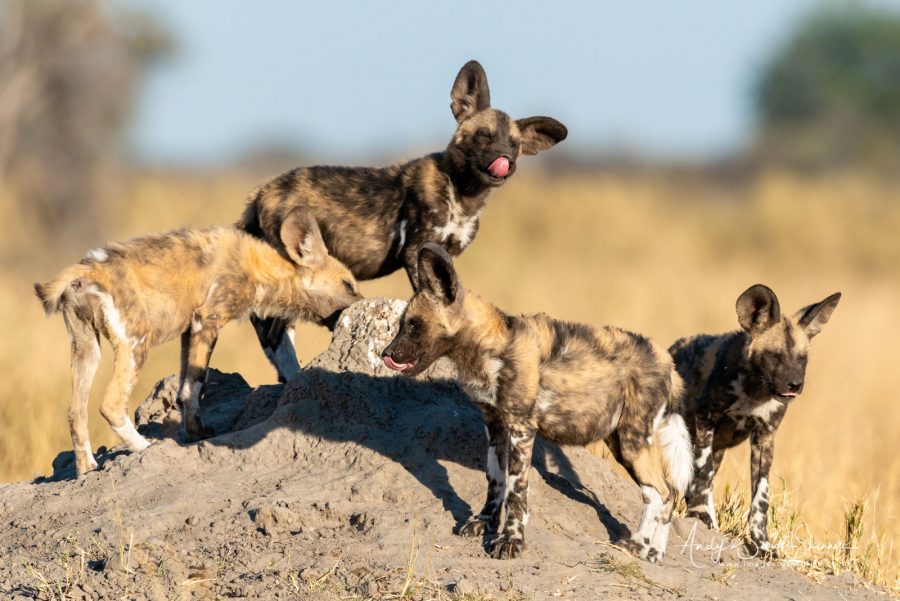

0,170,900,582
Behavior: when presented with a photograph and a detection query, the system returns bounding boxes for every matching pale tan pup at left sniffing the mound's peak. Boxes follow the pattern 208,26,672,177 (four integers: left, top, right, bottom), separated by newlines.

35,209,361,475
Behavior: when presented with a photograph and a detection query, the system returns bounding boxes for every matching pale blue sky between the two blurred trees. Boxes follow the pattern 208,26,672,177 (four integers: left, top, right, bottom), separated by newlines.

119,0,836,164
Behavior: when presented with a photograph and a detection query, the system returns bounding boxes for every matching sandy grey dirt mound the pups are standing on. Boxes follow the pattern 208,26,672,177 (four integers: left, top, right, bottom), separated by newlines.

0,299,880,599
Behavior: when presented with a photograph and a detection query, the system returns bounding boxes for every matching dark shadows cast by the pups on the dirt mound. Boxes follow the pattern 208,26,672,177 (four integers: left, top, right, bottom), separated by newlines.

35,368,628,540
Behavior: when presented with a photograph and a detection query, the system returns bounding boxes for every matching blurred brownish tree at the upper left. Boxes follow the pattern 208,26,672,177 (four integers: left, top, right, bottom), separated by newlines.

0,0,171,244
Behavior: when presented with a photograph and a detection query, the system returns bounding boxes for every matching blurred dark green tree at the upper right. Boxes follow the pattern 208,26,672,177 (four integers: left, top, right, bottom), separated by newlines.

757,2,900,168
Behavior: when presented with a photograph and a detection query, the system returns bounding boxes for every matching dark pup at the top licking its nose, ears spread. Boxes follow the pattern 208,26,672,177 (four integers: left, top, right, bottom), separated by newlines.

238,61,567,381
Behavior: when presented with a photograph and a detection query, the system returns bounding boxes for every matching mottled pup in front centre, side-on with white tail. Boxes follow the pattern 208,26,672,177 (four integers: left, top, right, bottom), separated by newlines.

382,244,693,561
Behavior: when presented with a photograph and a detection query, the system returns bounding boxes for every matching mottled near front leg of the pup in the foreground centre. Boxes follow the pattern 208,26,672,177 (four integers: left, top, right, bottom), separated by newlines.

491,426,535,559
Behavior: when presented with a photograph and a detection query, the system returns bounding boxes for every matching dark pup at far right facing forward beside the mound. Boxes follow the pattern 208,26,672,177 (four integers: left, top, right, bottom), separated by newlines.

669,284,841,554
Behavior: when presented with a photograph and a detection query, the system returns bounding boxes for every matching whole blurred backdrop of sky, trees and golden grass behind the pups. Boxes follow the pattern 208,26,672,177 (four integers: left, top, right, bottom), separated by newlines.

0,0,900,587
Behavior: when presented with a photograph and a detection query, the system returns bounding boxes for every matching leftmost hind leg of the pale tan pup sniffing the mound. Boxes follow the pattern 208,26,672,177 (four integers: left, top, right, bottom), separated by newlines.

63,310,100,476
